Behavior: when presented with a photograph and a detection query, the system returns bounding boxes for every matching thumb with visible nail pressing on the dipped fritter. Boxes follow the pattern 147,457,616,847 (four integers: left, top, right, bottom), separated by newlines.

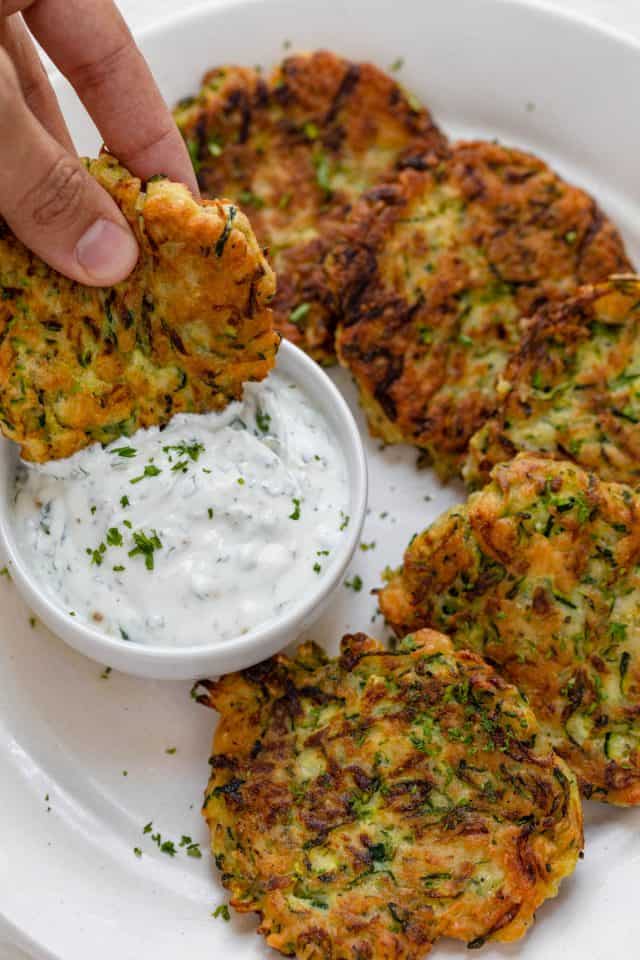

0,48,138,286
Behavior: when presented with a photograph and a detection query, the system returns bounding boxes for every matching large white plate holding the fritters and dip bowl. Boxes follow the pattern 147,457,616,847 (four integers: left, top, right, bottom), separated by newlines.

0,0,640,960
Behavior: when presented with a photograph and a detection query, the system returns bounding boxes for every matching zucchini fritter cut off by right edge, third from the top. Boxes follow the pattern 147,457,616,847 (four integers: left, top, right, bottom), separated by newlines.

463,275,640,488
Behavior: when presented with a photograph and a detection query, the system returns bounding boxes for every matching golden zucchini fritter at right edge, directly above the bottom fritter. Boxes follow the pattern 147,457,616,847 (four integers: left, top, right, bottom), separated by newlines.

380,454,640,804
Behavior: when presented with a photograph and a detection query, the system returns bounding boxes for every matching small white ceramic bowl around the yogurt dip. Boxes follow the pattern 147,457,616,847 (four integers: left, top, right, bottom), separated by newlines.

0,340,367,680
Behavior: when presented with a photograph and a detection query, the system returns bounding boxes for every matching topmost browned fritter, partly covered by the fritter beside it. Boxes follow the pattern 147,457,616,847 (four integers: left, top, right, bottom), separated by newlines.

175,50,445,363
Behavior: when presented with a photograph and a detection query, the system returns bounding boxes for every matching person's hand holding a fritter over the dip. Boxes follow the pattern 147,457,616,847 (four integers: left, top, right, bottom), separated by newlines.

0,0,198,286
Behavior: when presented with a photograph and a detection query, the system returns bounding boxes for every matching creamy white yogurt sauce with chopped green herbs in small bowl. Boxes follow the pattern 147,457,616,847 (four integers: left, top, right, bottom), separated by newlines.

13,372,349,647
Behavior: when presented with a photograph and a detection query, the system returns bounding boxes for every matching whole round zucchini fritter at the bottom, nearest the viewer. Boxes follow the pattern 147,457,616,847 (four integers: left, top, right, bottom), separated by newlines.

203,630,582,960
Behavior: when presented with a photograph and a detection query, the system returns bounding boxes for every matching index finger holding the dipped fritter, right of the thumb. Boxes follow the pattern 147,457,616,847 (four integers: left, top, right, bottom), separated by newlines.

23,0,198,195
